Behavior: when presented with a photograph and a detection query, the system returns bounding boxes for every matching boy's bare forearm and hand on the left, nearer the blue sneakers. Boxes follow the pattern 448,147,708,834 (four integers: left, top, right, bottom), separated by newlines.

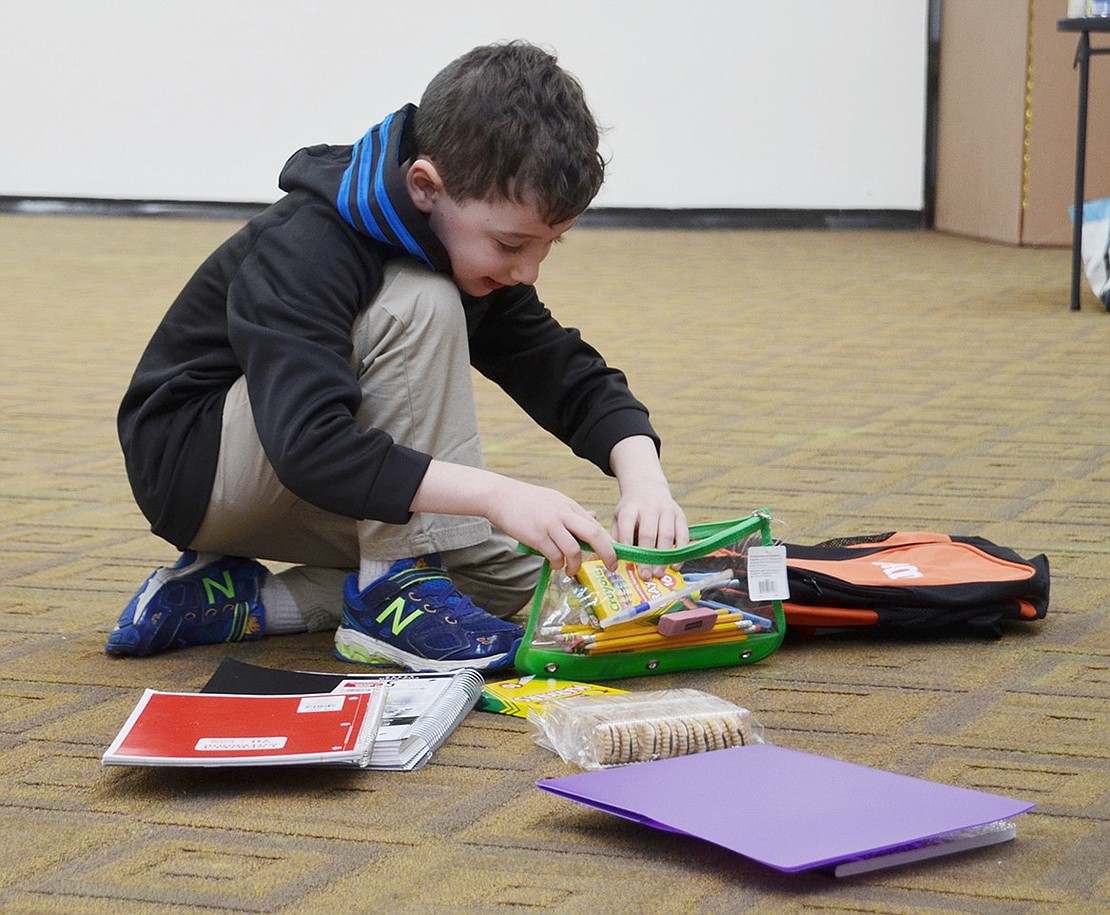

411,460,617,576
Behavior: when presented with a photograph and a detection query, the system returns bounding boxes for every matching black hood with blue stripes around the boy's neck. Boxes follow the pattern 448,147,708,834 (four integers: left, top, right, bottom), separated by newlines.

278,104,451,273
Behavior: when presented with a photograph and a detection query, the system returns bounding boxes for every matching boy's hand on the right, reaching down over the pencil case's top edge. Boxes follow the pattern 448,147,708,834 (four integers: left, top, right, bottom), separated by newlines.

609,435,690,577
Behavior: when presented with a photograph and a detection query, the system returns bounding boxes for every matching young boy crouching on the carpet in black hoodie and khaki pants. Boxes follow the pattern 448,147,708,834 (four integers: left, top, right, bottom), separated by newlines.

107,42,688,670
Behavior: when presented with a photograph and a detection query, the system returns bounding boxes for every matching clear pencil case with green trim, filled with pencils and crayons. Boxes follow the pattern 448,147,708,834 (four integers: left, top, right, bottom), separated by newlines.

515,510,786,682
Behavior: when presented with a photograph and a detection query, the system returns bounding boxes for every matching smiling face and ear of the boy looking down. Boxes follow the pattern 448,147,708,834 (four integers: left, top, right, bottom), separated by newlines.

408,159,574,296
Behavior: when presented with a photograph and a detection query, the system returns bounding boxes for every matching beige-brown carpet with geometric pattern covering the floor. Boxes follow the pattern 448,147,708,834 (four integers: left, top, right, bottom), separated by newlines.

0,215,1110,915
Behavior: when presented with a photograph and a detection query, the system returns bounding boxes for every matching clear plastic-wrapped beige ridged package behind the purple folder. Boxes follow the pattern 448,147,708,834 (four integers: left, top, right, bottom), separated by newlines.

528,690,763,768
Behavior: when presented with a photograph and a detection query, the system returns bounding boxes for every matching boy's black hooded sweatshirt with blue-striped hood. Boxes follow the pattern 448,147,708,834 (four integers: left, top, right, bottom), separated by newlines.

118,105,658,550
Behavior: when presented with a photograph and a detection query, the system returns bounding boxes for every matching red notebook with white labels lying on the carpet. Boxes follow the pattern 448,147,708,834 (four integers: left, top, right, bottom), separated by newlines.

102,685,385,768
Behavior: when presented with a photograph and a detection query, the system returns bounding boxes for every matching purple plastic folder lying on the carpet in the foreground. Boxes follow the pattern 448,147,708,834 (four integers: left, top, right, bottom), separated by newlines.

537,744,1035,872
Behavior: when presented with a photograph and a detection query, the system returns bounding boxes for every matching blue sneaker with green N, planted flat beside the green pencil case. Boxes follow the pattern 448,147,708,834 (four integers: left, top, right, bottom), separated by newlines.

335,555,524,671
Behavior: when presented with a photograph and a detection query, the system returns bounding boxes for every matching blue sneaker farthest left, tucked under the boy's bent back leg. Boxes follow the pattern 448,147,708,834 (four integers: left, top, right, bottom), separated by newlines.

104,550,266,656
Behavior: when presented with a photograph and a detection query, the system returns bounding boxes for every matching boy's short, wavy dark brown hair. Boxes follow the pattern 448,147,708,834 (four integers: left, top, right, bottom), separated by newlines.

415,41,605,225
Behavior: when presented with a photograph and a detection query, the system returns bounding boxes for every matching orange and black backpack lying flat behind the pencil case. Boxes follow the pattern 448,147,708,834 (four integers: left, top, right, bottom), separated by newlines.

783,531,1049,635
